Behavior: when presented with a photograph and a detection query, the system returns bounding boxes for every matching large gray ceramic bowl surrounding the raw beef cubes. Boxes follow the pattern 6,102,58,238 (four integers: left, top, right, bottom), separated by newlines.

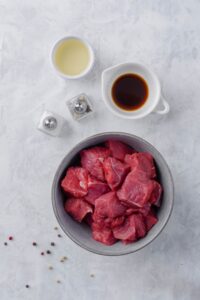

52,132,174,255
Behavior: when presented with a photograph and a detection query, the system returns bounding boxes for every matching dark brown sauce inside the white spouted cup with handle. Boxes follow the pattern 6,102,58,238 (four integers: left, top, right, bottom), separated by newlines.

112,74,149,111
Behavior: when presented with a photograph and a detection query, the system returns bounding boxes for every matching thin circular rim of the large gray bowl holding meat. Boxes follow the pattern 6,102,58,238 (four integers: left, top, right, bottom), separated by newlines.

51,131,174,256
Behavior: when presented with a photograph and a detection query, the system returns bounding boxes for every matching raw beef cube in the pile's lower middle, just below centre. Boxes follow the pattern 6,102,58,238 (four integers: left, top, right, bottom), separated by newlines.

95,192,126,218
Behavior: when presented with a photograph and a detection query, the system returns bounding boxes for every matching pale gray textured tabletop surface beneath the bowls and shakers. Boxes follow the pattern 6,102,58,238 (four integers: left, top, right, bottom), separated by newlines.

0,0,200,300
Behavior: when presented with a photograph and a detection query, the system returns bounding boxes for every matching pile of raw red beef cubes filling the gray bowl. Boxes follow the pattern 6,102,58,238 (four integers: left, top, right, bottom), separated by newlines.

61,140,162,245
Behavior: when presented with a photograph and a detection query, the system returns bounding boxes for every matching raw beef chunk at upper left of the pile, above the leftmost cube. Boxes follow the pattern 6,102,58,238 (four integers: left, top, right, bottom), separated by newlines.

81,147,110,181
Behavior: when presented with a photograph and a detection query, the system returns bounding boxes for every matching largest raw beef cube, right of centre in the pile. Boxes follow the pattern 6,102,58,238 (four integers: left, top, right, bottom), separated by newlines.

117,171,154,208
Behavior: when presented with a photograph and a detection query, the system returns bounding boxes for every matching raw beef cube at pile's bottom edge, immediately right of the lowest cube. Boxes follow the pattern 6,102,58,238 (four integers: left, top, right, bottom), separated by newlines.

113,215,137,243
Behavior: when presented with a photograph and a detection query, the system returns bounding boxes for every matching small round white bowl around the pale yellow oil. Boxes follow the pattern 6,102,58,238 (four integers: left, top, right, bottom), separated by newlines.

50,36,94,79
